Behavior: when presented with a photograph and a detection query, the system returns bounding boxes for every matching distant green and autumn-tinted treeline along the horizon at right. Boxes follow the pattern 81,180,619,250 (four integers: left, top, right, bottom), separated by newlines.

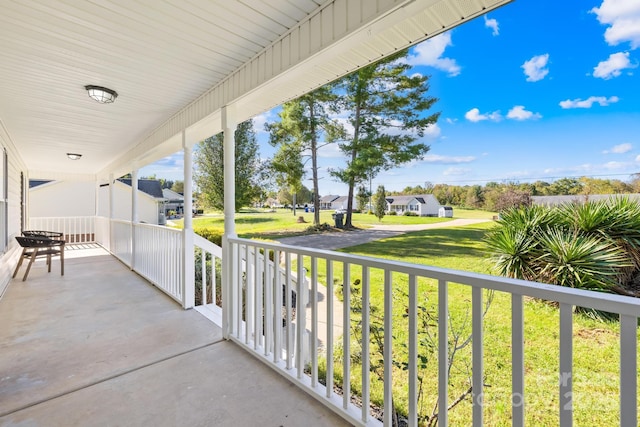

389,174,640,212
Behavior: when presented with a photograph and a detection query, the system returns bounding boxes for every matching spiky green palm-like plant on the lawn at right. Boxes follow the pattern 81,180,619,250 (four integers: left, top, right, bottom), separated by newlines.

486,198,640,295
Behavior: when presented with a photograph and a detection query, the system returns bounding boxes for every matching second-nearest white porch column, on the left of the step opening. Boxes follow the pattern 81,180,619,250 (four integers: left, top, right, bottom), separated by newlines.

182,130,195,309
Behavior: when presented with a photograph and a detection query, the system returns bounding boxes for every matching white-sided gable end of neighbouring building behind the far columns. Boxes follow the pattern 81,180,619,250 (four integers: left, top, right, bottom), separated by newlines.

98,178,167,225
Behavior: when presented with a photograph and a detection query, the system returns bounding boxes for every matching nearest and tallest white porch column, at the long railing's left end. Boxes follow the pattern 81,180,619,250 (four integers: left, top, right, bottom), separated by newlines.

222,106,237,338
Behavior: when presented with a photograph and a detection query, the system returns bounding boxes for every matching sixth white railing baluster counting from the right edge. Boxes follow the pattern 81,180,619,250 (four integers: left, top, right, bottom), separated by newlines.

408,274,418,427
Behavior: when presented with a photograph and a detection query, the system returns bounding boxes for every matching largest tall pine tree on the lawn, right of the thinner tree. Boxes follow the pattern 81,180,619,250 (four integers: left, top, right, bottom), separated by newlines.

331,50,439,227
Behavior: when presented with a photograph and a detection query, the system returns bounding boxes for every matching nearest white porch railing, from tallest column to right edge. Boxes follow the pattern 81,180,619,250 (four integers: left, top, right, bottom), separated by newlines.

225,238,640,427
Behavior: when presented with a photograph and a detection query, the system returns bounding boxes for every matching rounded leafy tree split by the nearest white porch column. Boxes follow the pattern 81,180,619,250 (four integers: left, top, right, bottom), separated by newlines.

194,120,264,212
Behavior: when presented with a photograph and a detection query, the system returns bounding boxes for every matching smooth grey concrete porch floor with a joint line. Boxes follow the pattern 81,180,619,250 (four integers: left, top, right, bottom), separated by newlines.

0,247,348,427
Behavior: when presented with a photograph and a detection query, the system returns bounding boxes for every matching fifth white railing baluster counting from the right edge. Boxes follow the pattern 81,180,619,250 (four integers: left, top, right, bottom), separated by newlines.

438,279,449,427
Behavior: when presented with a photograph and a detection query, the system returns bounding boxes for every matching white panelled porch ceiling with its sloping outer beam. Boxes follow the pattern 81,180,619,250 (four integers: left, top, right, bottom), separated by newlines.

0,0,511,178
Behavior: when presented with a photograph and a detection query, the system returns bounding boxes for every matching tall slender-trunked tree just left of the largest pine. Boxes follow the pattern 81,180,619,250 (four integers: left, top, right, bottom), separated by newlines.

266,85,344,225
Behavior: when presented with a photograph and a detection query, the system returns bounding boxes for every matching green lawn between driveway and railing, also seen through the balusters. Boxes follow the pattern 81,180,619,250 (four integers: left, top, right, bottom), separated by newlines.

307,223,636,426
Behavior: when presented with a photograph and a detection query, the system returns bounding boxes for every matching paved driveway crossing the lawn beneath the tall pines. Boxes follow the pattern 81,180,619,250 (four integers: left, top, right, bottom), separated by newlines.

279,219,490,250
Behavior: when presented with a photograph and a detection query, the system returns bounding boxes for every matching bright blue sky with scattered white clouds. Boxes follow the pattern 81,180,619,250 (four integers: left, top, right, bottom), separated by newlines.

140,0,640,195
